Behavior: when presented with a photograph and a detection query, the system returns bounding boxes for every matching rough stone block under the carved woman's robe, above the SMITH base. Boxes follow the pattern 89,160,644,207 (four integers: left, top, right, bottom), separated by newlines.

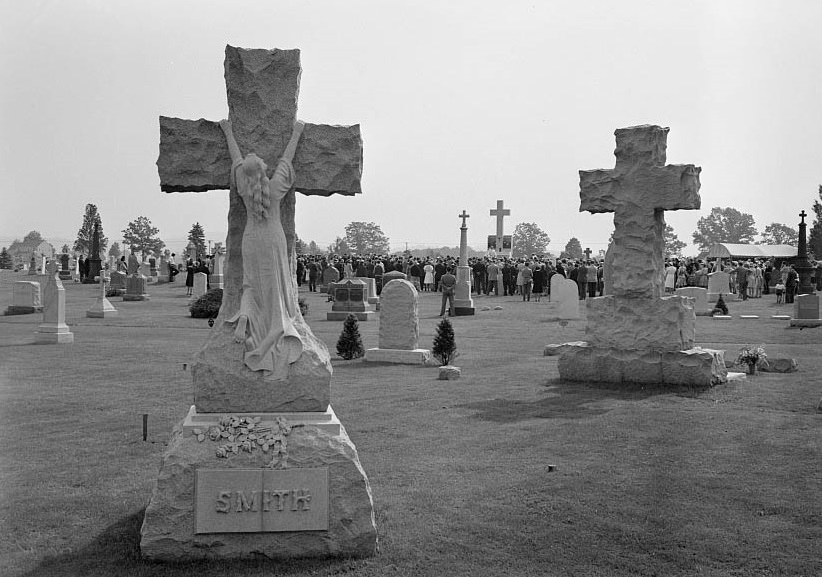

192,318,331,413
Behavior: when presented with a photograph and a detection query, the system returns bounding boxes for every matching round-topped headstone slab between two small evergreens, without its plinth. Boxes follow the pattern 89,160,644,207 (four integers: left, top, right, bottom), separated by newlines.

379,279,420,351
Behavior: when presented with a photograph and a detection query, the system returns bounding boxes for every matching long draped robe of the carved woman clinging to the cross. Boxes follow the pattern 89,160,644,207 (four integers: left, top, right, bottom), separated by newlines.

227,159,303,380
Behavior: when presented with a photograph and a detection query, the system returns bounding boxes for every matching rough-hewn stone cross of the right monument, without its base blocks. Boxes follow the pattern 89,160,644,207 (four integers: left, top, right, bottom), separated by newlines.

579,124,702,298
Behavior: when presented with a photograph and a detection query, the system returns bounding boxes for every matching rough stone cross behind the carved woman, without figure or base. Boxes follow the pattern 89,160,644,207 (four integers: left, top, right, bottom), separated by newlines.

157,46,362,317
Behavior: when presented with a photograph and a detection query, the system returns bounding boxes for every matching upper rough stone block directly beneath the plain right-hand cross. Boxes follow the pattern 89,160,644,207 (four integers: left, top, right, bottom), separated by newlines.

585,296,696,351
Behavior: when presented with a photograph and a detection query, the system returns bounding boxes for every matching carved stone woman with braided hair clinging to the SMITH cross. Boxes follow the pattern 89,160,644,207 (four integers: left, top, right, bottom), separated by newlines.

220,120,304,380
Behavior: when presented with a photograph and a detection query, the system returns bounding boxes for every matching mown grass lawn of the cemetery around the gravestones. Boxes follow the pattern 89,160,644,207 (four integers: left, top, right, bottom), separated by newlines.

0,271,822,577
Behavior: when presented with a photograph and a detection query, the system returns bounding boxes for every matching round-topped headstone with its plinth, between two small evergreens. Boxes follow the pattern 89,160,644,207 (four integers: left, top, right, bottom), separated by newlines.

365,279,431,365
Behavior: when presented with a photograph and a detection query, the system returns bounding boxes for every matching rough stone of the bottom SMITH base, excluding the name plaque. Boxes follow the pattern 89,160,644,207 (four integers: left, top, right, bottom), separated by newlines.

140,416,377,561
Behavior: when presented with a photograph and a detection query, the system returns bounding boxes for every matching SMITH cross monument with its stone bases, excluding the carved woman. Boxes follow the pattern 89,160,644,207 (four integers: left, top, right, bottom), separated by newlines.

140,46,377,561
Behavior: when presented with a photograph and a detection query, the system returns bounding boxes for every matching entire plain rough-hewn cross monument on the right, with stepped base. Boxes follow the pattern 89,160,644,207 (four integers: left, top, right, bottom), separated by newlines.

558,125,728,386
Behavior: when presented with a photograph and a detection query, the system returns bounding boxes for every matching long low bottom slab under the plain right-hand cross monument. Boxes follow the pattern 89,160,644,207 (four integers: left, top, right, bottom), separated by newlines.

558,343,728,387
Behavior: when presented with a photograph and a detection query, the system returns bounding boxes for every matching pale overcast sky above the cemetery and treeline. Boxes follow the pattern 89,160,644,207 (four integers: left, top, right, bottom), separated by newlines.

0,0,822,254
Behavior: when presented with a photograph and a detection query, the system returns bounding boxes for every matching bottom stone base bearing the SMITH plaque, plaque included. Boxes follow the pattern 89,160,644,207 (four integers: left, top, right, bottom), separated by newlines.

140,404,377,562
